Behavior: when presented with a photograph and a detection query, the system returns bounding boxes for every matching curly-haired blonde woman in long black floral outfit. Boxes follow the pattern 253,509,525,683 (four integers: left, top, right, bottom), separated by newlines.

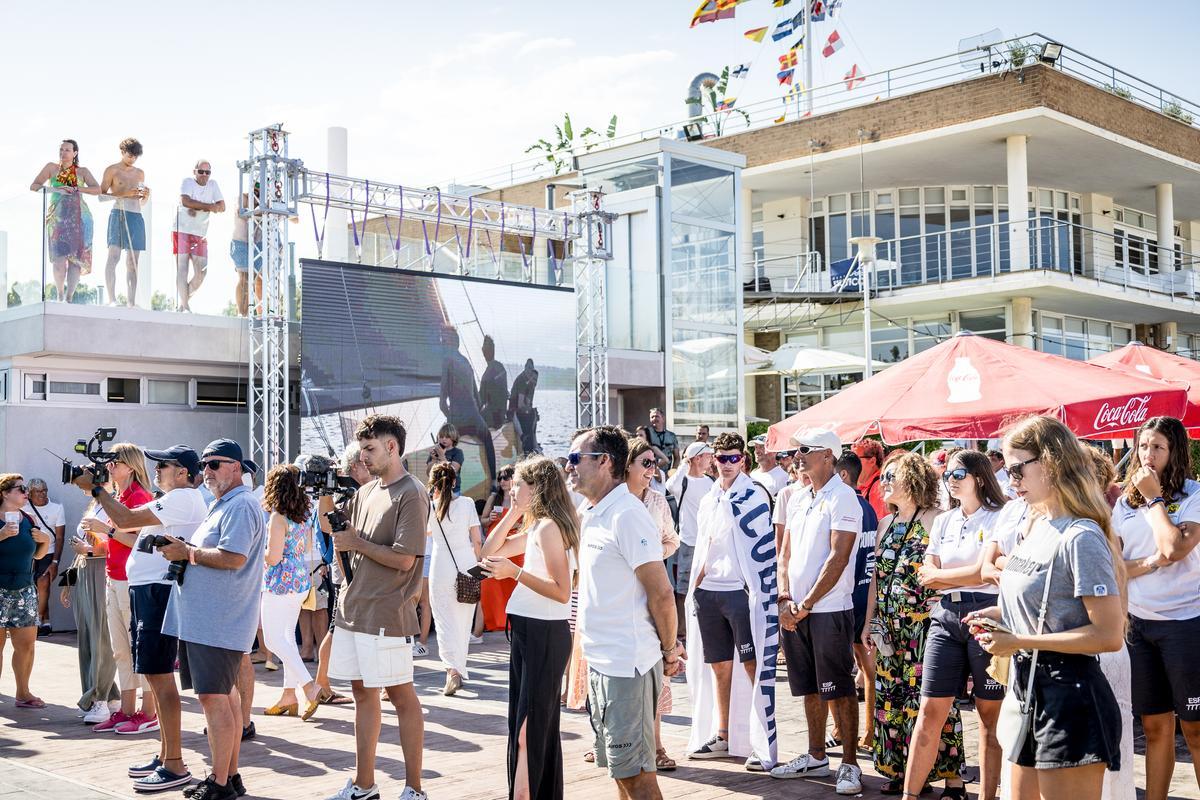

863,451,962,794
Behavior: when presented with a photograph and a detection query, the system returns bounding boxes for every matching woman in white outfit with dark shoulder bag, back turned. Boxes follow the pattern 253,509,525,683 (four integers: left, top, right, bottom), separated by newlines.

428,463,481,697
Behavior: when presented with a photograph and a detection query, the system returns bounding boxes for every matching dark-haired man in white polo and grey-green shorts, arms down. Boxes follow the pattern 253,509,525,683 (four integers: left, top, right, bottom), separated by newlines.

566,426,683,800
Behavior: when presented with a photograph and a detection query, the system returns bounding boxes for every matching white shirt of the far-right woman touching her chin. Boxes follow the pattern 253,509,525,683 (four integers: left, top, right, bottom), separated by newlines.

1112,480,1200,620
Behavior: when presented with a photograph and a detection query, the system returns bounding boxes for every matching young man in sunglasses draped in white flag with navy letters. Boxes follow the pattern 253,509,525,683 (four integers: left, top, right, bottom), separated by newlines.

686,433,779,771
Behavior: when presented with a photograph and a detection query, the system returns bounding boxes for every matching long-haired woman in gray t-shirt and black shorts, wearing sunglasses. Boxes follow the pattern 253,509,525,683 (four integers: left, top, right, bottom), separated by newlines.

970,416,1124,800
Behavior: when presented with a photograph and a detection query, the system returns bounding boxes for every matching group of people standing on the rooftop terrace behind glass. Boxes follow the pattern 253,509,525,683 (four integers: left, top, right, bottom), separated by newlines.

30,138,262,317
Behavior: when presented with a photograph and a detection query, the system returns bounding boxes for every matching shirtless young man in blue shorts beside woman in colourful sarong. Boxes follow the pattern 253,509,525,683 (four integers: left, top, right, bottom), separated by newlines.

100,138,150,307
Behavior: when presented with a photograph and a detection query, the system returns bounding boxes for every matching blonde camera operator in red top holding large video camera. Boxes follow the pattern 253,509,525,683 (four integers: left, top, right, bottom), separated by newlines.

72,441,158,734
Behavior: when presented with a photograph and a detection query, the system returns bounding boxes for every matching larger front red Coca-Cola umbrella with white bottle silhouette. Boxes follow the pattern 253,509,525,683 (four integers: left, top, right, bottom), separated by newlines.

767,332,1187,450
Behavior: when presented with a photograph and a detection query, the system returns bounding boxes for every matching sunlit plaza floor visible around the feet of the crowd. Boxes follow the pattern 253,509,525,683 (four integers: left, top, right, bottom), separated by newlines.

0,633,1200,800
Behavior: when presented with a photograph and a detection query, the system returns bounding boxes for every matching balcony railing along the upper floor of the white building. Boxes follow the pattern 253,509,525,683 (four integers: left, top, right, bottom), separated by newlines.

745,218,1200,299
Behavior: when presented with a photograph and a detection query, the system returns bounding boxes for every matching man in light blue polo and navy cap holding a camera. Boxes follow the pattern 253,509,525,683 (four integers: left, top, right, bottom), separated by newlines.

158,439,266,800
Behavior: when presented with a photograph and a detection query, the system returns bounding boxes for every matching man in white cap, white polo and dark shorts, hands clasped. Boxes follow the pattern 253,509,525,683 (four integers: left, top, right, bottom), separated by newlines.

770,429,863,794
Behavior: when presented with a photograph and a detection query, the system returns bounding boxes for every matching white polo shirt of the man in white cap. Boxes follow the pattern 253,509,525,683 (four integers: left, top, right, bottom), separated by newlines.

785,475,863,613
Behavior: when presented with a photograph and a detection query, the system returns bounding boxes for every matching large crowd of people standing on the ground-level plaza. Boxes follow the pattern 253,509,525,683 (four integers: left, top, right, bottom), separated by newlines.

0,409,1200,800
